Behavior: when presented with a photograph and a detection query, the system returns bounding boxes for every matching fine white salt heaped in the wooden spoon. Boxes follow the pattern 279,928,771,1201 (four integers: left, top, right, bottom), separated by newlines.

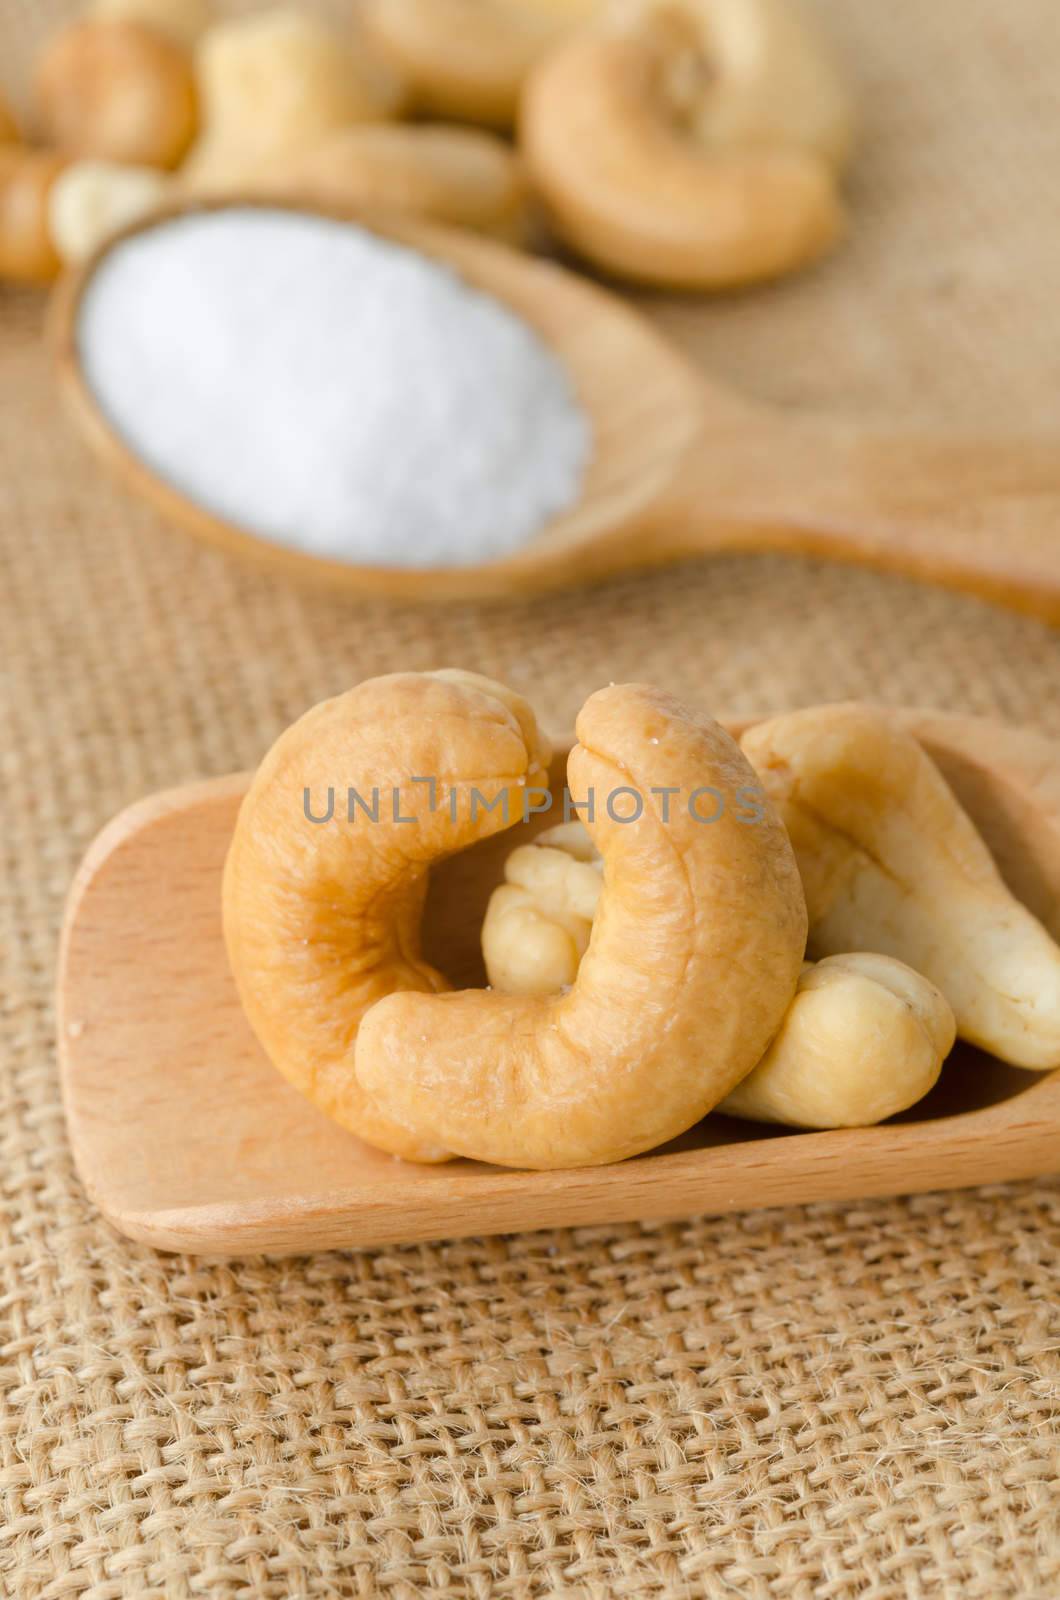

77,208,589,566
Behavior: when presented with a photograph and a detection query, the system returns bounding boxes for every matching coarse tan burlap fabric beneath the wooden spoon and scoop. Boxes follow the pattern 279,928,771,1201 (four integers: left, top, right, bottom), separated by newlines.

0,0,1060,1600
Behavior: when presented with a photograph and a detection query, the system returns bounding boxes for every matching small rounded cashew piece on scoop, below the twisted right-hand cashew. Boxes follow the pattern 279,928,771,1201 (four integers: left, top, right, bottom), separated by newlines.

717,952,956,1128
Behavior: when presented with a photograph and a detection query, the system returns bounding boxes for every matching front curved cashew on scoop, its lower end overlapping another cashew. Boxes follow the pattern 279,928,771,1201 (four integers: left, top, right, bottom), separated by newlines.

354,685,805,1168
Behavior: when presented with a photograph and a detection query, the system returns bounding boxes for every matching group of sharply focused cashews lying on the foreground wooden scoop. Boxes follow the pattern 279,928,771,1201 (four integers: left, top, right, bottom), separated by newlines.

223,670,1060,1168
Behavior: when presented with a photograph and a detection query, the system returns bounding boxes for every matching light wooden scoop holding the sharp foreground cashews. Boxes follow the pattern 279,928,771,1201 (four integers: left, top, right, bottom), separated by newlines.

59,712,1060,1254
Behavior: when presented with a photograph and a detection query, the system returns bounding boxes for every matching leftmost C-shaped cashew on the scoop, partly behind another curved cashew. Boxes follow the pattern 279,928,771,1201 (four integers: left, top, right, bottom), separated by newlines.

223,672,549,1162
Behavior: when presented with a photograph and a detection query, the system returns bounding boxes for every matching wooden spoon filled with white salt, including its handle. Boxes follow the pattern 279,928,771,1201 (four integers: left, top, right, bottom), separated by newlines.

54,198,1060,622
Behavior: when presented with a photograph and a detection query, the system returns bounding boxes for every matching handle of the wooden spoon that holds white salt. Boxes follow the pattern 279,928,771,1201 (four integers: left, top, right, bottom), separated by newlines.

658,418,1060,624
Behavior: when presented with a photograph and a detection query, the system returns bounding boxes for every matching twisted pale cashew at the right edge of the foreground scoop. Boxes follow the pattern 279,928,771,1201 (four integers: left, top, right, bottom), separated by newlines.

741,706,1060,1069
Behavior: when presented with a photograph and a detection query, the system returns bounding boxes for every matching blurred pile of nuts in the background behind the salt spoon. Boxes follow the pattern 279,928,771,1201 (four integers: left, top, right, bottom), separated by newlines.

0,0,852,290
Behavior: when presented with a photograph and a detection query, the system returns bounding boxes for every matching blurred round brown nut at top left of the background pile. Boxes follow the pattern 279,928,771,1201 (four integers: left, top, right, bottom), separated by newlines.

35,19,199,168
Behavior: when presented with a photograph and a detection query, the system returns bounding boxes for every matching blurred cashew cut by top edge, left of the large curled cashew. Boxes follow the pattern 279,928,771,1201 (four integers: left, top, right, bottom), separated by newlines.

367,0,602,128
